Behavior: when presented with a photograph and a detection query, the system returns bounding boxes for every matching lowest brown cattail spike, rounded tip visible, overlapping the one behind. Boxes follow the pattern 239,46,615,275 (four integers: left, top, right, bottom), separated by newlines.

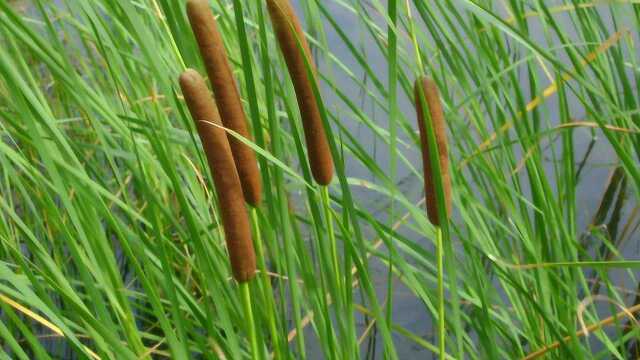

180,69,256,282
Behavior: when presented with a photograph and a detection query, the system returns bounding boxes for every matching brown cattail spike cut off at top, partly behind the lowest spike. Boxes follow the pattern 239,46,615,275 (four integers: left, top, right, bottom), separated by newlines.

187,0,262,206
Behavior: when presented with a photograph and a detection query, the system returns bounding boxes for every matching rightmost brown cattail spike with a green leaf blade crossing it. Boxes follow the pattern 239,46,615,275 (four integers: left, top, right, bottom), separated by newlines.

415,78,451,226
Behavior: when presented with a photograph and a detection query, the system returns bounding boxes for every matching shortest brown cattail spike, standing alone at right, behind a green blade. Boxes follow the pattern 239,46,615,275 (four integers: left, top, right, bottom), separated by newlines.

415,78,451,226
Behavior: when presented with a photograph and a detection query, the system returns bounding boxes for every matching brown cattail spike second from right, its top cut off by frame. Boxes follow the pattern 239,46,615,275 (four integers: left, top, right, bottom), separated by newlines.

267,0,333,185
